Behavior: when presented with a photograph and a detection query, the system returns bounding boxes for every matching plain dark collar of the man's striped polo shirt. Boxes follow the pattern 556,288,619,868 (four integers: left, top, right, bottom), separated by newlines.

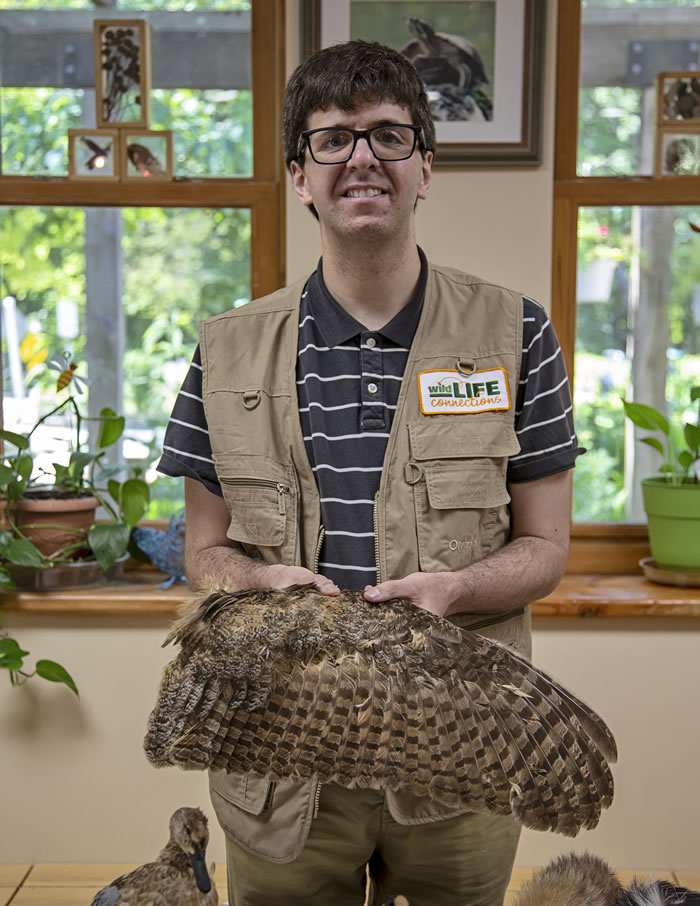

307,247,428,348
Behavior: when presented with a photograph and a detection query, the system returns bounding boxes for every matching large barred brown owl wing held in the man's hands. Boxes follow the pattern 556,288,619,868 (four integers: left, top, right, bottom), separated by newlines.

144,586,617,836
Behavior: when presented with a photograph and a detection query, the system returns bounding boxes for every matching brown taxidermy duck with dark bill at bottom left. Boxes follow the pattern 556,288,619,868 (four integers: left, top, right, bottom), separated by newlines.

91,808,219,906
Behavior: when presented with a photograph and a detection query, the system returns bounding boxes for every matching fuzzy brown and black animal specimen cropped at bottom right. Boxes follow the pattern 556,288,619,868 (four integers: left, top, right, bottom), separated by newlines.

513,853,700,906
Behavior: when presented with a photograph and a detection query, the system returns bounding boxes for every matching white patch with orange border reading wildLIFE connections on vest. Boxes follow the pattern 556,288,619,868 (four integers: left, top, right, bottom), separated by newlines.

418,368,510,415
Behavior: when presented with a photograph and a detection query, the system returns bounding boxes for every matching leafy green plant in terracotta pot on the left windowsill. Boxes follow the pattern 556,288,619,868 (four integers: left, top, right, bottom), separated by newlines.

0,363,149,589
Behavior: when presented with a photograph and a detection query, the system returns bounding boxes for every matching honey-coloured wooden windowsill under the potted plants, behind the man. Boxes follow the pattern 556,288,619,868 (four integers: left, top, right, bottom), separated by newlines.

0,569,700,618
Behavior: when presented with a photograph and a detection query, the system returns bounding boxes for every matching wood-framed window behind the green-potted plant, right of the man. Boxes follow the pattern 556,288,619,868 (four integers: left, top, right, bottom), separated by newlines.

552,0,700,552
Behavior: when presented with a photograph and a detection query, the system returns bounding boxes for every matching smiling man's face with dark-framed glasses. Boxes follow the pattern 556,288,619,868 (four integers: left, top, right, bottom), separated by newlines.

290,102,433,238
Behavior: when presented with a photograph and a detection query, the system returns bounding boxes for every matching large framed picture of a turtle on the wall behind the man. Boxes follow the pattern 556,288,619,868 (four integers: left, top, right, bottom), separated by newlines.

301,0,545,167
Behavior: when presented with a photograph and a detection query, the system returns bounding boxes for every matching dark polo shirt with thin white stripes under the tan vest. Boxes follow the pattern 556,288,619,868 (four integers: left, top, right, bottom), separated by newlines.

158,252,581,588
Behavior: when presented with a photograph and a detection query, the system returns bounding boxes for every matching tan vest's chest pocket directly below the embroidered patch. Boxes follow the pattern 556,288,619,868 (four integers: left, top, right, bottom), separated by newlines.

406,416,519,572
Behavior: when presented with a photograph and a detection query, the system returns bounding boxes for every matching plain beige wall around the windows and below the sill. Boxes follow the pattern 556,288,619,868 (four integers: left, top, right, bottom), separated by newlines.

0,2,700,869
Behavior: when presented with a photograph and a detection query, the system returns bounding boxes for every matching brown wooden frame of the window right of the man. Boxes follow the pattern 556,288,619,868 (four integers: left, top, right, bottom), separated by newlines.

552,0,700,573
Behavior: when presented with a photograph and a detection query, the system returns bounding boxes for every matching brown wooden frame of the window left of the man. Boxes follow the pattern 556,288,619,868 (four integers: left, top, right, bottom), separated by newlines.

0,0,286,299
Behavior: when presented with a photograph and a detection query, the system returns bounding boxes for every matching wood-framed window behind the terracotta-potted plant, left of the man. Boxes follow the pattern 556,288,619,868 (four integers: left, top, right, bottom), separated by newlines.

0,0,284,518
